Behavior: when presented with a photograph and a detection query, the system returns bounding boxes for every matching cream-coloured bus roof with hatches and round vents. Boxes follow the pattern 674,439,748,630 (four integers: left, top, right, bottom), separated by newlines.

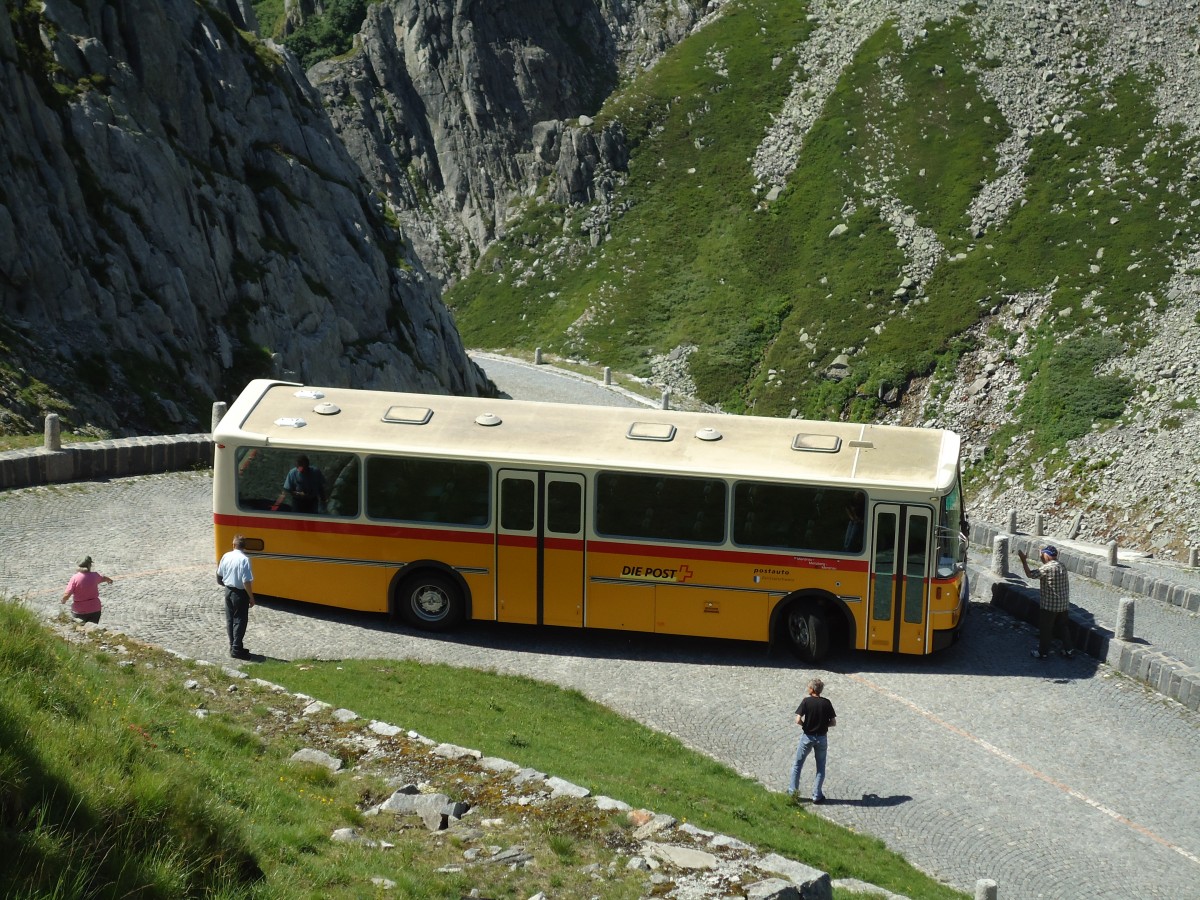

214,379,960,494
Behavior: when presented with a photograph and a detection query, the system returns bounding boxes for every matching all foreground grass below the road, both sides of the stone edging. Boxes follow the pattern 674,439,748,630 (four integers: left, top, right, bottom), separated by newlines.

0,602,960,900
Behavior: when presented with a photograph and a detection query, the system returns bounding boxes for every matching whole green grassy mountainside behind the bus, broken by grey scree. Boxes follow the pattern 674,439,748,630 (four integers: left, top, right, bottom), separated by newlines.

446,0,1196,472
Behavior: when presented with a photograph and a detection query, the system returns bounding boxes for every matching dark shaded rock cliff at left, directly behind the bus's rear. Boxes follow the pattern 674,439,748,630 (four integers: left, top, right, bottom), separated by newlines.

0,0,490,431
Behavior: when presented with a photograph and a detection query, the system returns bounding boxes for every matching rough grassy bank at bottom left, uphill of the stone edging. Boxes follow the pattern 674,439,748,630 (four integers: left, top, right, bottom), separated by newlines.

0,601,646,900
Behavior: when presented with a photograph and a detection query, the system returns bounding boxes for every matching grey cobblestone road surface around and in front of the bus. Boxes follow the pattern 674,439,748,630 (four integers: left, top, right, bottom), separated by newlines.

0,473,1200,900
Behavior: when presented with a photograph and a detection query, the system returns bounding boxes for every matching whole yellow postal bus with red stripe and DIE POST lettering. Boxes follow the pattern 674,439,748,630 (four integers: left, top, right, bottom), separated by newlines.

212,380,967,661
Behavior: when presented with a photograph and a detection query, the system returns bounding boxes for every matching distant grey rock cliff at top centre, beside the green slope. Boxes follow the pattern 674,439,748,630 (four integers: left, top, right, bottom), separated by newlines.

308,0,718,280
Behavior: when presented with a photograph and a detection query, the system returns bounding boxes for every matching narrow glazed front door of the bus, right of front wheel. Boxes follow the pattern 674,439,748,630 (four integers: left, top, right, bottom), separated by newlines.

866,504,932,653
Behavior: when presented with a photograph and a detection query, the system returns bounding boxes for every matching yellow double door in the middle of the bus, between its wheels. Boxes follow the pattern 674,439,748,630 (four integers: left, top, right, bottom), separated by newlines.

496,469,584,626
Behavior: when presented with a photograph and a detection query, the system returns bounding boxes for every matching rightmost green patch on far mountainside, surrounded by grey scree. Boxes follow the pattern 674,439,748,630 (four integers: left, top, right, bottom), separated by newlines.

950,76,1196,480
